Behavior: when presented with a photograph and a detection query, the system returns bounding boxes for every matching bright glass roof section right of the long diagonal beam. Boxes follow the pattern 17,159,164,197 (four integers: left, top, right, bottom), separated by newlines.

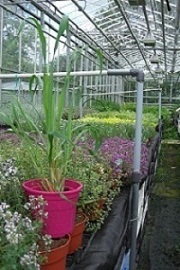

50,0,180,76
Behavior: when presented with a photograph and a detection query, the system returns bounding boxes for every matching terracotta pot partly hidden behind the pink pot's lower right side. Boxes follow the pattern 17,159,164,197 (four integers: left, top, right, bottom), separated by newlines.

68,213,88,254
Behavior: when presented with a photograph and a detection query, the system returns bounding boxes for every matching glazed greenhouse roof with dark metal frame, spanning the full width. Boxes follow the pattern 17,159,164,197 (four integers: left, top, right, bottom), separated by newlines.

0,0,180,81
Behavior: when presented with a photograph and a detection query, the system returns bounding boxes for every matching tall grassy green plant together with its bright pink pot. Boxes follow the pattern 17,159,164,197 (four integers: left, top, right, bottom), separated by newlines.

2,16,90,238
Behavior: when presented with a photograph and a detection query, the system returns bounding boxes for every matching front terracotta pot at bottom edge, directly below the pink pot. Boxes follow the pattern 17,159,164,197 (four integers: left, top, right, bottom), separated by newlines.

39,235,71,270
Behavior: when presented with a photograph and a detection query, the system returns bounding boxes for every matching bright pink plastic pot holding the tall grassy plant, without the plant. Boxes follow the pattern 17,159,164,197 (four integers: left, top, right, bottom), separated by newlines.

23,179,83,238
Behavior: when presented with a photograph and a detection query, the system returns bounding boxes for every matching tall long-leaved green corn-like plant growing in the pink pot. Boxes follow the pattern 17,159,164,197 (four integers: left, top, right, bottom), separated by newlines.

0,16,100,191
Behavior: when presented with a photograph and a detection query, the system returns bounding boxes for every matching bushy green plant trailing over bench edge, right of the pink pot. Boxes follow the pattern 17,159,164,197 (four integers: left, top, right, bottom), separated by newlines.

69,146,122,233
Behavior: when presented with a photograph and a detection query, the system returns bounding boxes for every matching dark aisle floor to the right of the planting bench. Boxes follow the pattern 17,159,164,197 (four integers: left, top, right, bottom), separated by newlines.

137,144,180,270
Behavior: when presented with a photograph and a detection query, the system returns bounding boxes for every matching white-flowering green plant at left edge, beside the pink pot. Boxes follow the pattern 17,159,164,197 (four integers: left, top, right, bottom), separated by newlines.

0,156,51,270
